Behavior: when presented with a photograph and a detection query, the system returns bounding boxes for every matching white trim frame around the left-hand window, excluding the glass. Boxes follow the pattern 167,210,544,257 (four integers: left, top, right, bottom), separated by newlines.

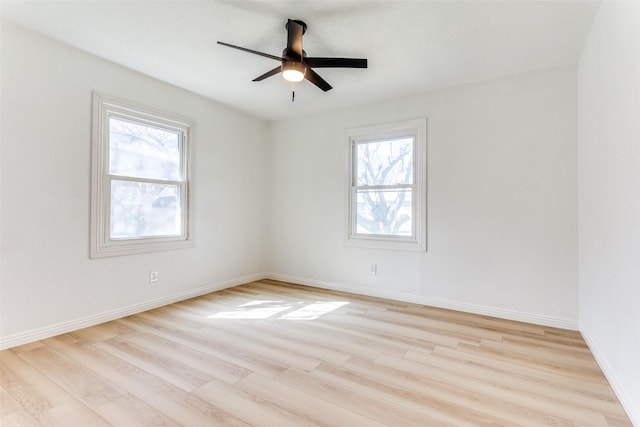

90,92,194,258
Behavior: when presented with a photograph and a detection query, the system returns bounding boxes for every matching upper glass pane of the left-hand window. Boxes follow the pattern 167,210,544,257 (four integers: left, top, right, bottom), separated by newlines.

109,117,182,181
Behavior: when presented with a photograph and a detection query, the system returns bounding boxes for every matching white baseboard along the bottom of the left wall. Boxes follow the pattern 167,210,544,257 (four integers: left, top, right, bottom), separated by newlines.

0,273,265,350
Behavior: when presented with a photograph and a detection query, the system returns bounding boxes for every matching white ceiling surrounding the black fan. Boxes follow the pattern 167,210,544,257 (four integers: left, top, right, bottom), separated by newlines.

1,0,600,120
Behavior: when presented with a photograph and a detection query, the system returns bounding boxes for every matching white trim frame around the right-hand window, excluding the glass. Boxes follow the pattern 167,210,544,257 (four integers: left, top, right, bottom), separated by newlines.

345,118,427,252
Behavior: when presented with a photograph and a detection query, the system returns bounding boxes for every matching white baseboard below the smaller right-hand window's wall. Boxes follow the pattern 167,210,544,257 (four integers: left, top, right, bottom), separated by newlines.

266,273,578,331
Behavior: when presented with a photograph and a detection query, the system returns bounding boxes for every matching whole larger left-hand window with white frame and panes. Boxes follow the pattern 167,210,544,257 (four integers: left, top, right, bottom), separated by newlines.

91,93,192,258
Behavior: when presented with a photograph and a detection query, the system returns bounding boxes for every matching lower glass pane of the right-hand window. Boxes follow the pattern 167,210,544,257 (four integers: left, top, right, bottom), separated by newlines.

355,189,413,236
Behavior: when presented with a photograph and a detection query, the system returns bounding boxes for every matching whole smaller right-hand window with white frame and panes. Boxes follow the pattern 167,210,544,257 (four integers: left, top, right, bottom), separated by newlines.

347,119,427,251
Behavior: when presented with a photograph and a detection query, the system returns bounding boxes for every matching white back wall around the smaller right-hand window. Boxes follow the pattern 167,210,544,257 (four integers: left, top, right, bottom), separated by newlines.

270,69,578,328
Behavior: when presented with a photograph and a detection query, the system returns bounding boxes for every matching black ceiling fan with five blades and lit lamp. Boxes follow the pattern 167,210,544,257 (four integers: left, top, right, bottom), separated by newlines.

218,19,367,95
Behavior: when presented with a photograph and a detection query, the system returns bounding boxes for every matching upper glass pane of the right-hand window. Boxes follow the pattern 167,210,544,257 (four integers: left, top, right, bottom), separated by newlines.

355,137,413,185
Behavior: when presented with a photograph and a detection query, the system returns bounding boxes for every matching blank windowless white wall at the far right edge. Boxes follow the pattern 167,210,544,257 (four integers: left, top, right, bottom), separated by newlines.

578,1,640,426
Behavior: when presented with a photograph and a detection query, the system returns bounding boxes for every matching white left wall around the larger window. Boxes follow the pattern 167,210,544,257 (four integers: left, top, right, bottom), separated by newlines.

0,22,268,344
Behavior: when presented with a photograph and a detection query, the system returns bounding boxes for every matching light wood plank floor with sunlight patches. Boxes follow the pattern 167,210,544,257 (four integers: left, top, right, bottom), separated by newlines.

0,280,631,427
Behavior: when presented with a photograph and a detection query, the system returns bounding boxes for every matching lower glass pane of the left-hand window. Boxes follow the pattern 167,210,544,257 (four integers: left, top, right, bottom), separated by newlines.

110,180,182,239
